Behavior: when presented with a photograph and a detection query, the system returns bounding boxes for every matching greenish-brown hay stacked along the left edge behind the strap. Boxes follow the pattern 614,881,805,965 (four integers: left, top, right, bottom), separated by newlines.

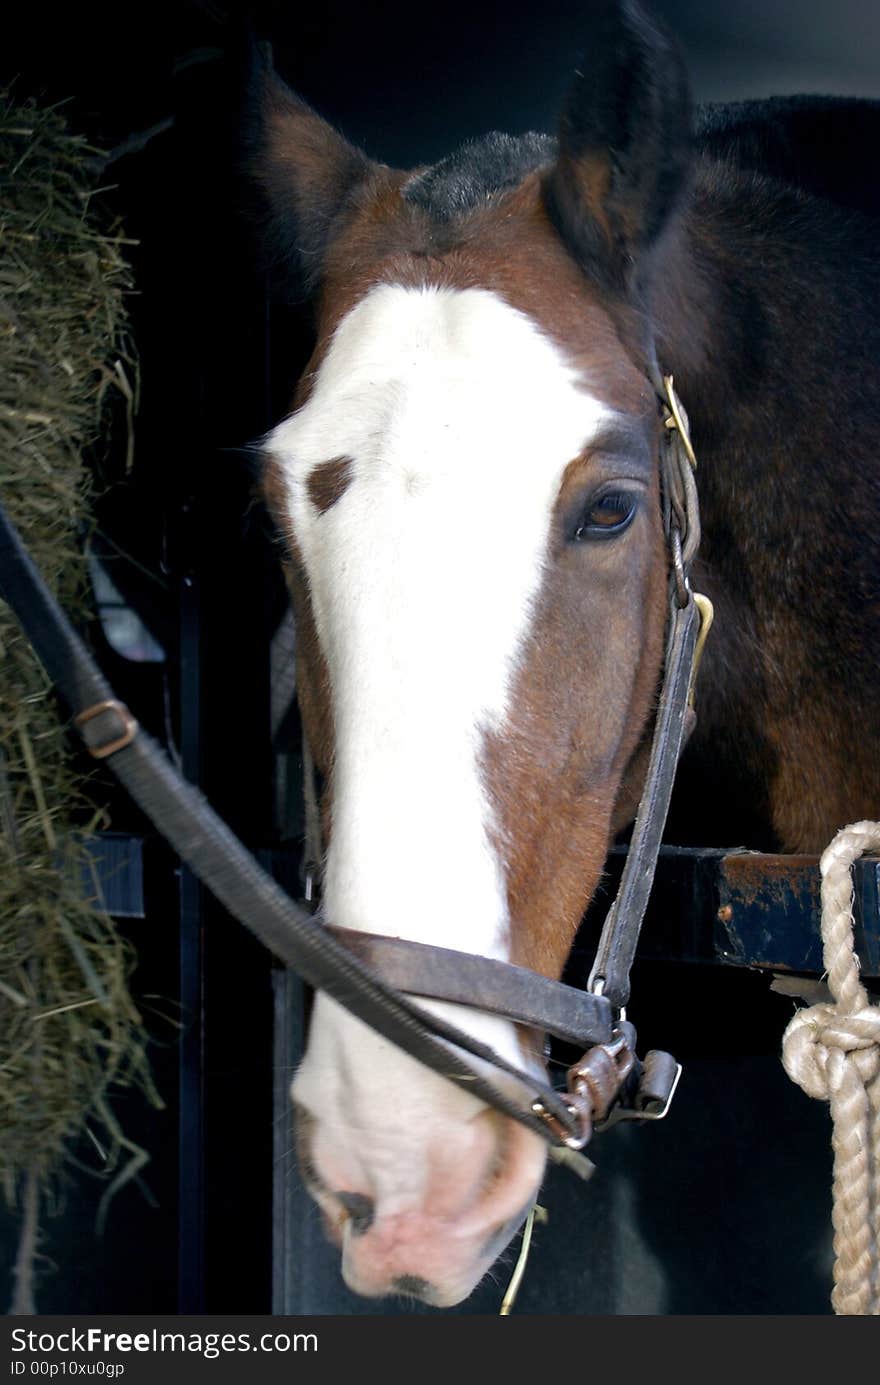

0,93,161,1312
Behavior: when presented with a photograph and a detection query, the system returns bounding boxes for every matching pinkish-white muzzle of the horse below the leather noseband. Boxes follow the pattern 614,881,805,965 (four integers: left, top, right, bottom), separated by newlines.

294,1024,546,1307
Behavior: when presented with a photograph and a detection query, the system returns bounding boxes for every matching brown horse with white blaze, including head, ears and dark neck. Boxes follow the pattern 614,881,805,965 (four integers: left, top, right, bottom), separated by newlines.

245,0,880,1306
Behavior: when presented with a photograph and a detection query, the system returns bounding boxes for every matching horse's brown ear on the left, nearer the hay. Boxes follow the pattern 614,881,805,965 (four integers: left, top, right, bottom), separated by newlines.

243,42,374,295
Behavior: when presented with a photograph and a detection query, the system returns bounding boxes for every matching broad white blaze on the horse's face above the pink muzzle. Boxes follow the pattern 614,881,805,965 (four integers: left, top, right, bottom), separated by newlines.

267,285,608,1085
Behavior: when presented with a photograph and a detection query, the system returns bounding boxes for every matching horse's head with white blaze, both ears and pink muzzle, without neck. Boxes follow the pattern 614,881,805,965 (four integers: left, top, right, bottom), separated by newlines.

251,0,690,1305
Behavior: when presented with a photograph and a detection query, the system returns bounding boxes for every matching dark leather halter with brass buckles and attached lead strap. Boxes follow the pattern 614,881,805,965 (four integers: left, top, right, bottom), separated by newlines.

0,377,711,1150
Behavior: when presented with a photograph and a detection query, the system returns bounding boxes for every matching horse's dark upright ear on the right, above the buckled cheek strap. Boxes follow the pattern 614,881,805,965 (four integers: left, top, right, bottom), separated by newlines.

546,0,692,292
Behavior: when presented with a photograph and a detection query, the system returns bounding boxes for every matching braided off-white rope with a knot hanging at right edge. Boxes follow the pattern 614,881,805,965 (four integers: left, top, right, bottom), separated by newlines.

782,823,880,1316
